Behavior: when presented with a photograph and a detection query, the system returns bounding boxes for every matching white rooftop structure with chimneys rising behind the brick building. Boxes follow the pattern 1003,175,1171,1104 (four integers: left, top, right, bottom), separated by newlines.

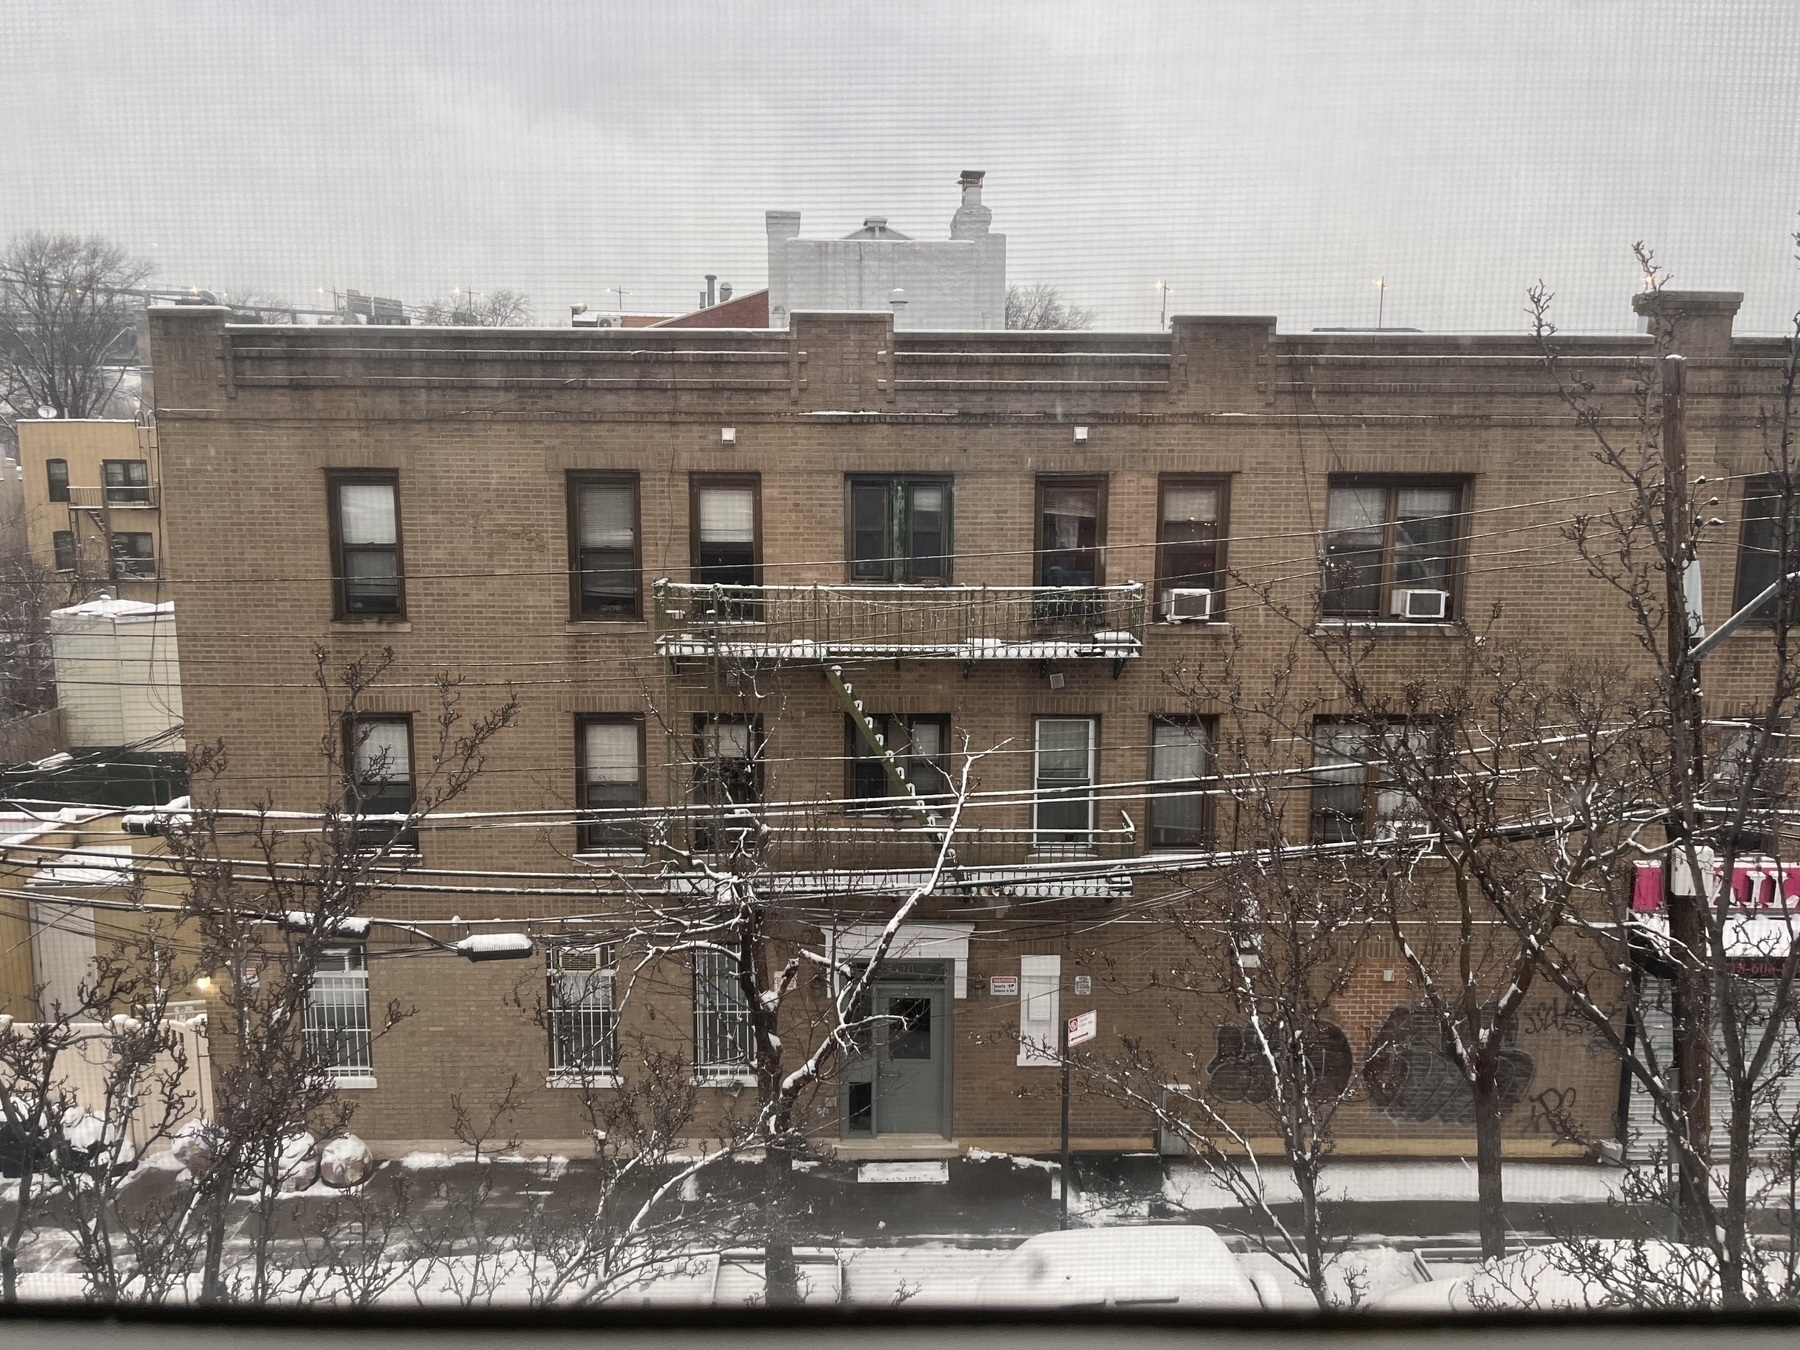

767,169,1006,329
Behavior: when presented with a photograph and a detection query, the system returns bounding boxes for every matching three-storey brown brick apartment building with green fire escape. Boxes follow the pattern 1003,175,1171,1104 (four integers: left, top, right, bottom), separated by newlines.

126,293,1784,1156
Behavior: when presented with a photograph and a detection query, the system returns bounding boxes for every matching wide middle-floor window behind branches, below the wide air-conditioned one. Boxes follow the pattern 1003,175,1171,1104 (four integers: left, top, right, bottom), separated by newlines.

1312,720,1431,844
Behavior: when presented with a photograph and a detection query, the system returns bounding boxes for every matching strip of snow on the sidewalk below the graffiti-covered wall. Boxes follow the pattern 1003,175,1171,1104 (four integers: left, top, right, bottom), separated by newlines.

1163,1161,1622,1211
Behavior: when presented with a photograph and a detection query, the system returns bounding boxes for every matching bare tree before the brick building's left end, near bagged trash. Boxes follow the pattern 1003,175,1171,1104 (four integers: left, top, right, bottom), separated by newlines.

166,650,517,1301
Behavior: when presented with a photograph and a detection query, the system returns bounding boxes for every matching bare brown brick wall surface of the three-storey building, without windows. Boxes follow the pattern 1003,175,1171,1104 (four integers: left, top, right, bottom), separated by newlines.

151,308,1778,1154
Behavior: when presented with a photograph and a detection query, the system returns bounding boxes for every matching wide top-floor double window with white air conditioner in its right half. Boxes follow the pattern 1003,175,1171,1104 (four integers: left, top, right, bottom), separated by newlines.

1319,479,1462,619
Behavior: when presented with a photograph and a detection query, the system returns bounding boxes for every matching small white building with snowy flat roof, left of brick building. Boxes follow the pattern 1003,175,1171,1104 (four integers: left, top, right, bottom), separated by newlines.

50,599,184,751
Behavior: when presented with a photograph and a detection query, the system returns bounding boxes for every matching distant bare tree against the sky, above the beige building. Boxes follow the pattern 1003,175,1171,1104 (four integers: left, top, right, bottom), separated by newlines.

0,230,151,427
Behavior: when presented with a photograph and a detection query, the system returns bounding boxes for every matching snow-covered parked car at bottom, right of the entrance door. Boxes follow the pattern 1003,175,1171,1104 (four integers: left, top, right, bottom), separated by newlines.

976,1224,1280,1310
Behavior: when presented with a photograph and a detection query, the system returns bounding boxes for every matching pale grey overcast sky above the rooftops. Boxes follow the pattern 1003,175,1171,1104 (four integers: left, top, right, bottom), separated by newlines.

0,0,1800,331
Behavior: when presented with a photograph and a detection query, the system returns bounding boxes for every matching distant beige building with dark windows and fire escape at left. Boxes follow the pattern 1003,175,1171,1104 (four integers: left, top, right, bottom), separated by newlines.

18,418,169,603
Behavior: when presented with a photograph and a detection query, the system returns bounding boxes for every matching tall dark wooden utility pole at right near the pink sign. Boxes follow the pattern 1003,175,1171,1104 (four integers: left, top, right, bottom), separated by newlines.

1660,355,1712,1240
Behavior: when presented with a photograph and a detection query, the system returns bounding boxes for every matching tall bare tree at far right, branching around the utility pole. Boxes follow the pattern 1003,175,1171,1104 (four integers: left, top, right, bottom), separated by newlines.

1496,245,1800,1307
